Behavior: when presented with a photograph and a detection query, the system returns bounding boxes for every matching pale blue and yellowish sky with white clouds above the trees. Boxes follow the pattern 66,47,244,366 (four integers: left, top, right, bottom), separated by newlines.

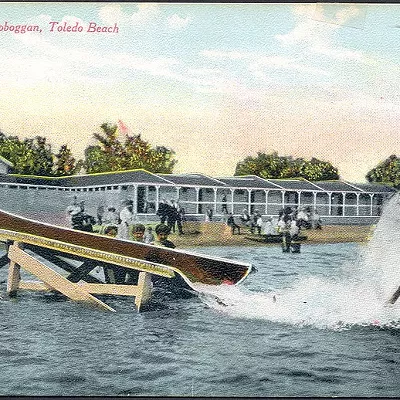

0,3,400,183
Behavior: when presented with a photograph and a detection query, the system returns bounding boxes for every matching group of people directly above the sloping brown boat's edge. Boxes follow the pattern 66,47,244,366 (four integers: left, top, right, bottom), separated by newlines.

66,196,175,248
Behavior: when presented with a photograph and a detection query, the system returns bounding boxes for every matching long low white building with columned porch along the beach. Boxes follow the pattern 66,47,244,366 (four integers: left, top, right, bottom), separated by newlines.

0,160,395,224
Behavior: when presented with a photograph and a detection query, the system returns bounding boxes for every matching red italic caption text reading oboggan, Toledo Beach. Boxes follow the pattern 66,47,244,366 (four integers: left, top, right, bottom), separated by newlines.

0,21,119,34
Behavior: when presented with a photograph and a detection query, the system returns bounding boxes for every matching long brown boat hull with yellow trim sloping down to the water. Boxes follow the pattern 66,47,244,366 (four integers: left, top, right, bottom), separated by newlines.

0,211,252,285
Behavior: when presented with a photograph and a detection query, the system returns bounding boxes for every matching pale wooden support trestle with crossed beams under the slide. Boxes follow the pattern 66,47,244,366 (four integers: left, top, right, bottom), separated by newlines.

7,242,158,311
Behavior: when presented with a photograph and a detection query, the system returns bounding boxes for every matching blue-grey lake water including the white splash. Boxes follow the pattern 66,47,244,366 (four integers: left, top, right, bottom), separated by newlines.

0,195,400,397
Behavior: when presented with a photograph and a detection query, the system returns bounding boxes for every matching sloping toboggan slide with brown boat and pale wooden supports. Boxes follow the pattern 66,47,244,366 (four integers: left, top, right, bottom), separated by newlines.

0,211,252,311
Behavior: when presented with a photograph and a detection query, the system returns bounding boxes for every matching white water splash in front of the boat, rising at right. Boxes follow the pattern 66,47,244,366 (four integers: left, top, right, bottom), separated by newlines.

195,195,400,330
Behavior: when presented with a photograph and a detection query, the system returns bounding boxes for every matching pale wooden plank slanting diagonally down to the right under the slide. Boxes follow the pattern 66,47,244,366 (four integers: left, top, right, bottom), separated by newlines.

9,245,115,311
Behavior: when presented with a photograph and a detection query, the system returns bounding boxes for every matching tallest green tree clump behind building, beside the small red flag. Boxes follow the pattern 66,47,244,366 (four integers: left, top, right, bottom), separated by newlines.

84,123,176,174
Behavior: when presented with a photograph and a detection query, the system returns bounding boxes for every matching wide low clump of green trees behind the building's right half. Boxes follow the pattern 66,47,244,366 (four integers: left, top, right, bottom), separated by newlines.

235,152,339,181
